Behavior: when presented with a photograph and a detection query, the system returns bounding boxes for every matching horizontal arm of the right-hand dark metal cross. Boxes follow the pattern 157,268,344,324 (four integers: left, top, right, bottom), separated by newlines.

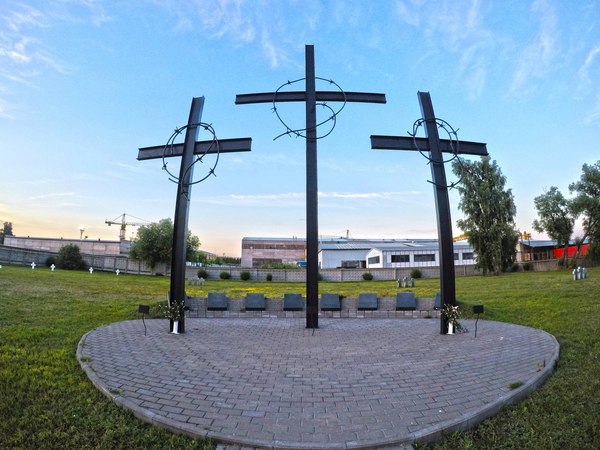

371,135,489,156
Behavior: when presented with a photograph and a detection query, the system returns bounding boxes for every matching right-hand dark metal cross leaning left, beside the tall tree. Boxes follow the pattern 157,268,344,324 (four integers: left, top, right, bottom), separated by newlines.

371,92,488,334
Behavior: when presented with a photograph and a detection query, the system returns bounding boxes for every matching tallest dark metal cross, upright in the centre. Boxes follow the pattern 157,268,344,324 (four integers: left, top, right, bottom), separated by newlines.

235,45,385,328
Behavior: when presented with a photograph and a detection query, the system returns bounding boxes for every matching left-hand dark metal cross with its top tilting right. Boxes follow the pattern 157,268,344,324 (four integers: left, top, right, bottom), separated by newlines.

137,97,252,333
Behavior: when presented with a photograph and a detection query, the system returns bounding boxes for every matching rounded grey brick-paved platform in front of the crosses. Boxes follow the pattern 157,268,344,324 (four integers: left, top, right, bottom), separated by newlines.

77,319,559,449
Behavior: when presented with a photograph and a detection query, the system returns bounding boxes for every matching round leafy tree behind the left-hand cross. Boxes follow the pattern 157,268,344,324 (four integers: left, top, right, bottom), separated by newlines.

129,219,200,269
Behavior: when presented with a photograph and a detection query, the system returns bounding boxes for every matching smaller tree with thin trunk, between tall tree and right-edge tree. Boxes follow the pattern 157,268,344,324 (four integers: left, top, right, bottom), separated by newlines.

533,186,575,267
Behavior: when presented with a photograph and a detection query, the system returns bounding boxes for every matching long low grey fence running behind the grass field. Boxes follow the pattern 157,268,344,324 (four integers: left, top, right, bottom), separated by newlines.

0,245,558,282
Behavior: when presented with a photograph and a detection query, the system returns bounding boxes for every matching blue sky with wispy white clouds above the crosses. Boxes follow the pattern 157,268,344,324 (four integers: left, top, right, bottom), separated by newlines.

0,0,600,255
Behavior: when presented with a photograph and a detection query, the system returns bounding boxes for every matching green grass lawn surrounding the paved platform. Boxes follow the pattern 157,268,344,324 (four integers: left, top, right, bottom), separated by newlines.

0,265,600,450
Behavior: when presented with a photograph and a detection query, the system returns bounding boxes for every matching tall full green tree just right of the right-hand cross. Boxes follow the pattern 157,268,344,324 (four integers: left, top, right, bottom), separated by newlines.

452,156,519,275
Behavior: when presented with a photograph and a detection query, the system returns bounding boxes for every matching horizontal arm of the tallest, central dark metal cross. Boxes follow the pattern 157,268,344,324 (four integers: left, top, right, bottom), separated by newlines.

235,91,386,105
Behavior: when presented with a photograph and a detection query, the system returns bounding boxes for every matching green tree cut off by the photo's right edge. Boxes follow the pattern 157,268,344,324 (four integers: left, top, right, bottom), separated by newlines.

569,161,600,261
